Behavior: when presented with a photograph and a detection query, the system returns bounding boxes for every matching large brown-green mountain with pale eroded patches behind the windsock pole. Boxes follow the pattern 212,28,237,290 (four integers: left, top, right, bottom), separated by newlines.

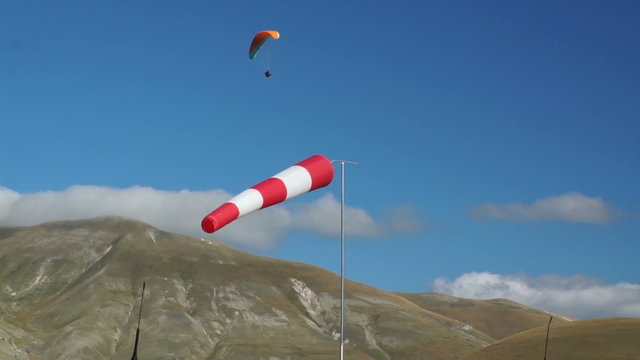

0,218,493,360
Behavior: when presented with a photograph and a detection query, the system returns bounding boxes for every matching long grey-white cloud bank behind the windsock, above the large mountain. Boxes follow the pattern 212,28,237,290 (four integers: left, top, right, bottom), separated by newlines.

0,185,419,249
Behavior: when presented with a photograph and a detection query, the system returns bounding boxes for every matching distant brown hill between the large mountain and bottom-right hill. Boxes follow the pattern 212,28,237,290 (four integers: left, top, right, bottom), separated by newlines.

398,293,571,340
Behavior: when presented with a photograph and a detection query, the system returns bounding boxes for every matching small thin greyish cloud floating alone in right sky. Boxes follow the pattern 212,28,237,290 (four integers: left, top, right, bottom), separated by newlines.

471,192,615,224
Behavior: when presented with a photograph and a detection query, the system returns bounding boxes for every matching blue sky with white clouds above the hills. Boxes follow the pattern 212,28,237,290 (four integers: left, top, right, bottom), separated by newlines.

0,1,640,317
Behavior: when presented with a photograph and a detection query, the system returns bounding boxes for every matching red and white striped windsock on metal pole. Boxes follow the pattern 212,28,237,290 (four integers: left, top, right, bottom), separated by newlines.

202,155,333,233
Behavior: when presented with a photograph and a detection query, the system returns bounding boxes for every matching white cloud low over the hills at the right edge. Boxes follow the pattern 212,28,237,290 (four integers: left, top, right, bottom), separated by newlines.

432,272,640,319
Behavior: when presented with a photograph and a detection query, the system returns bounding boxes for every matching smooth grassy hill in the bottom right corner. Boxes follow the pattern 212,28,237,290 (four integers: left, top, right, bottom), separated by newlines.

466,318,640,360
